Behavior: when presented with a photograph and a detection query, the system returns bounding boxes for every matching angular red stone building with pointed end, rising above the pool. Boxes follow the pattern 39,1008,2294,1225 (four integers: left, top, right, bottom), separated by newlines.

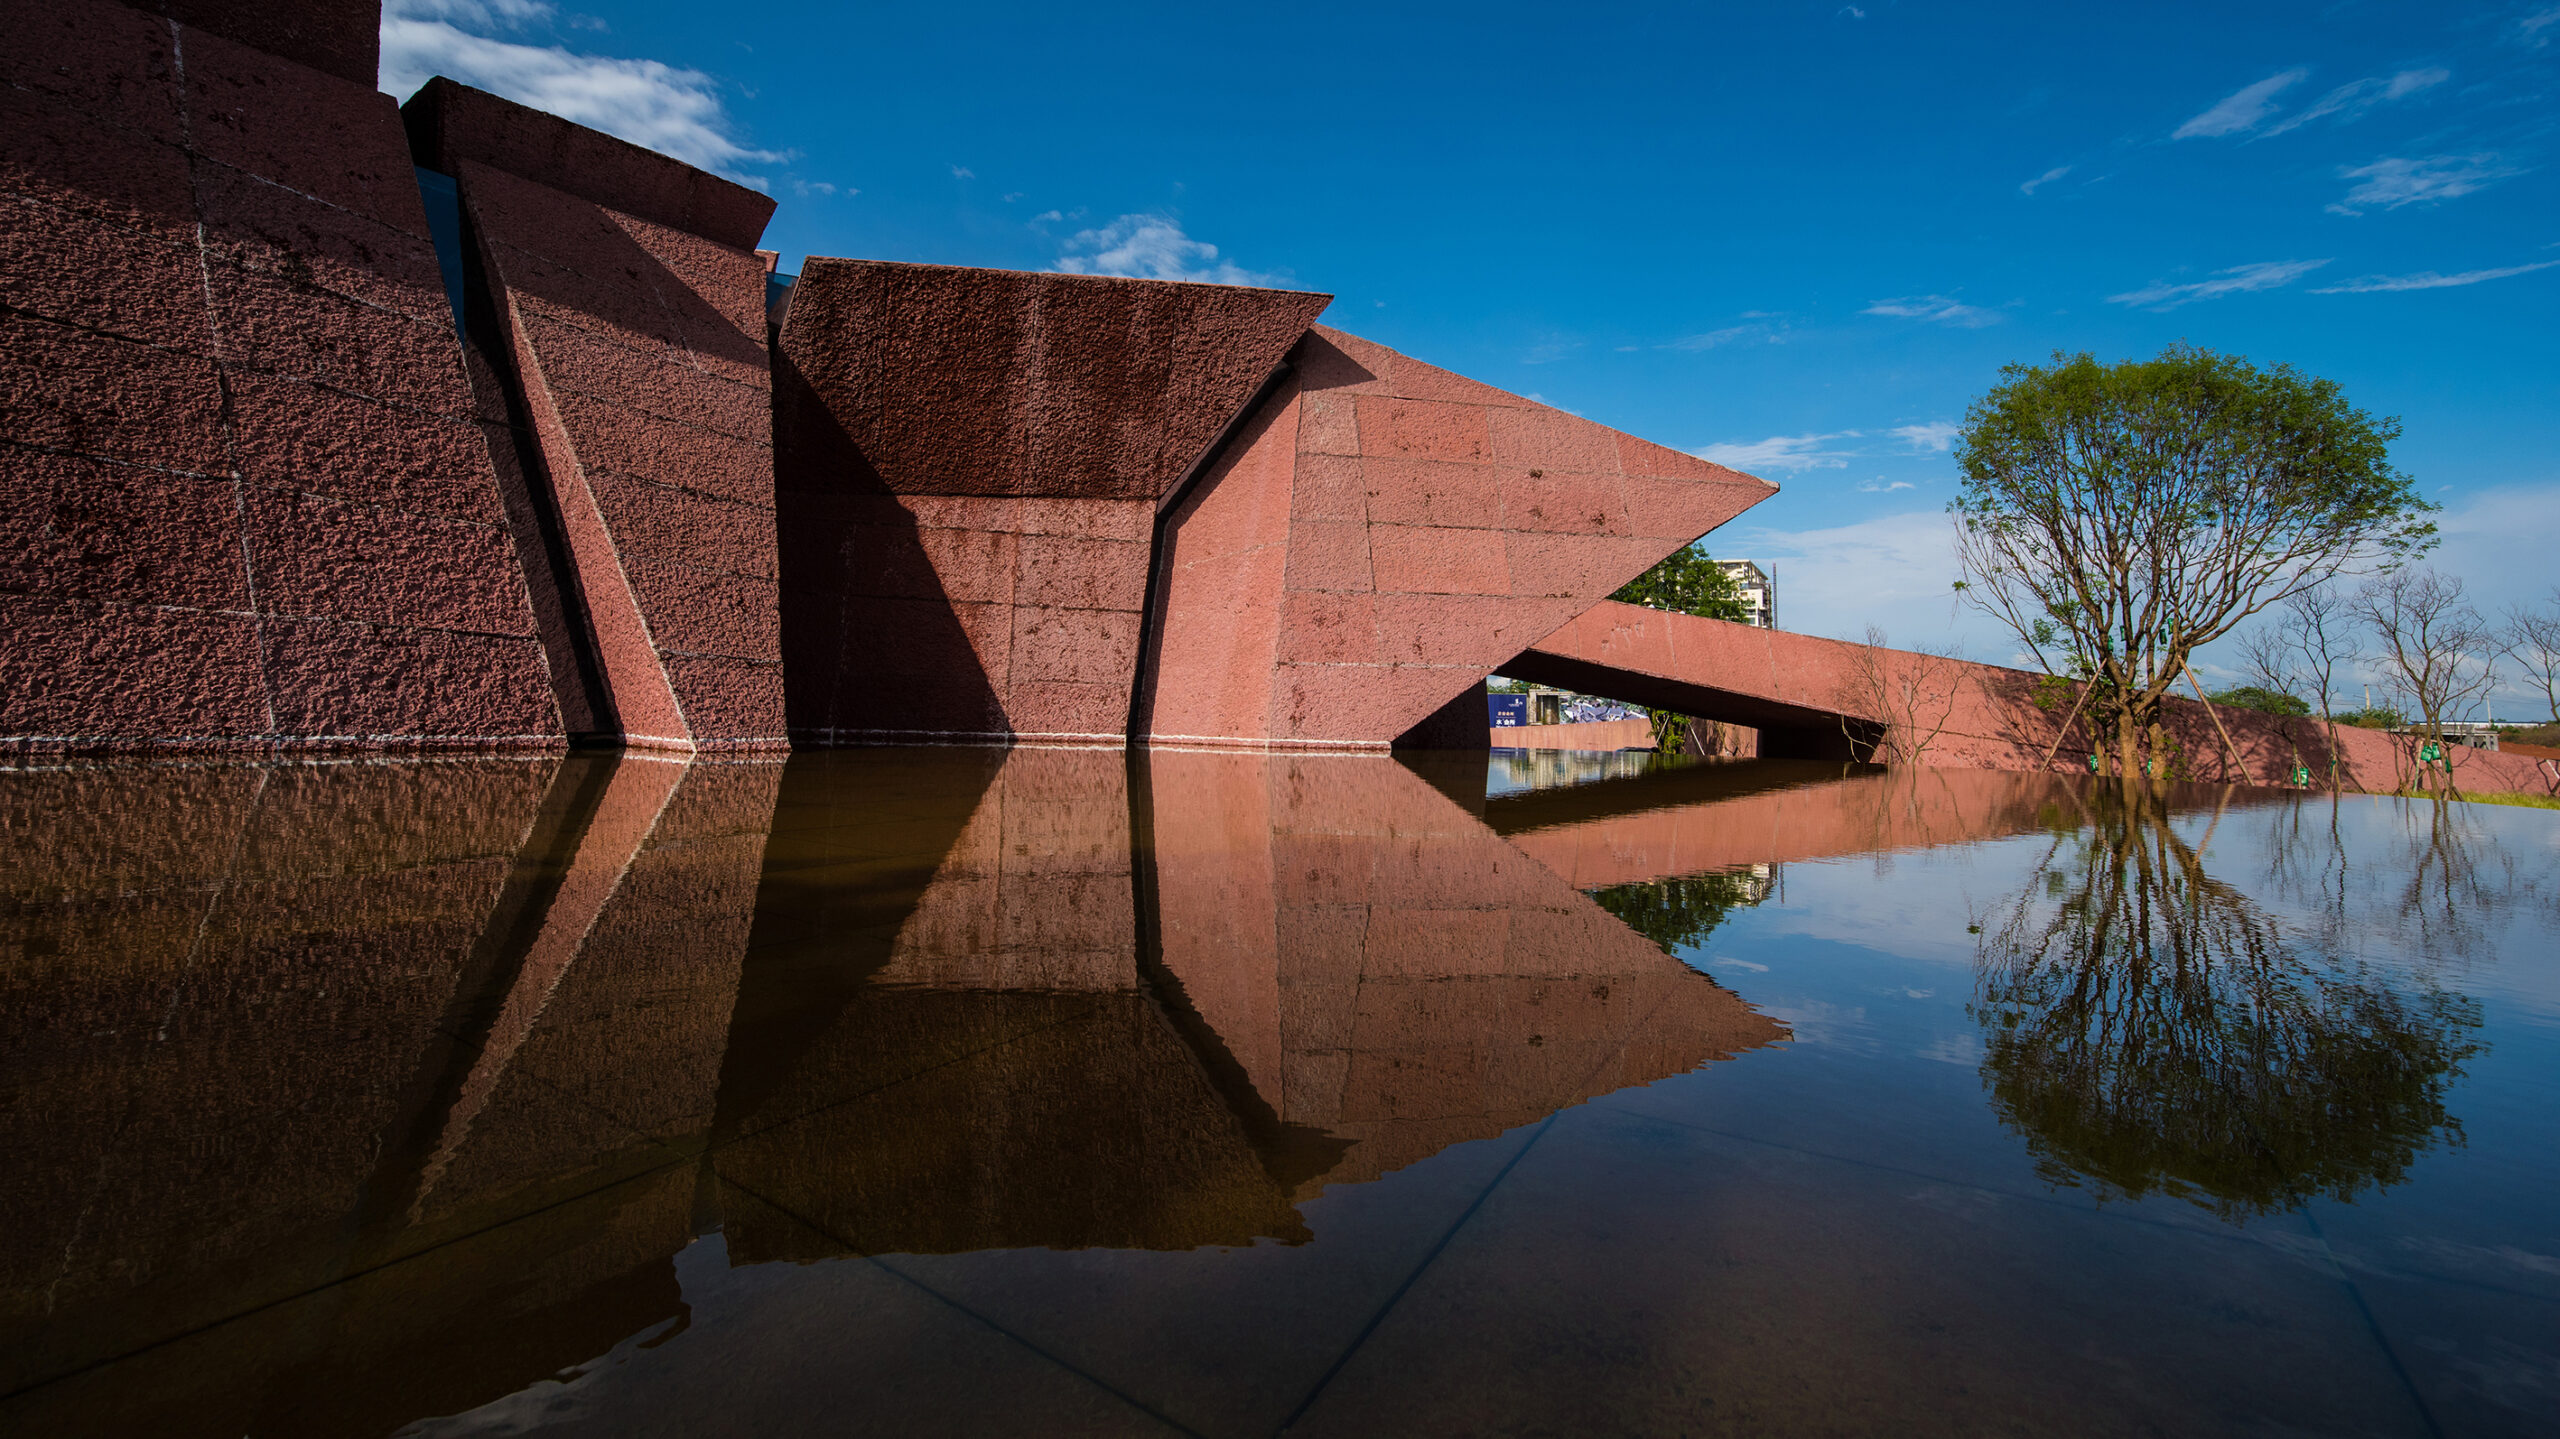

0,0,1802,753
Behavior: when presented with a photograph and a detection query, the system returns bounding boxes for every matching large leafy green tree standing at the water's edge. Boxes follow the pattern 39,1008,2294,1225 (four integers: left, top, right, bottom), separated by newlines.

1948,346,2435,776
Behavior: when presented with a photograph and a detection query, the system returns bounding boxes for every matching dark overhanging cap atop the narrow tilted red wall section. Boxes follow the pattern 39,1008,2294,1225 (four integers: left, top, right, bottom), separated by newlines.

399,74,773,251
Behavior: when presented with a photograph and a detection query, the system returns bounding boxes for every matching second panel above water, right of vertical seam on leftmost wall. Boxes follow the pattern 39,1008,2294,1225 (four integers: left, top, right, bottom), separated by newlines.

246,486,532,635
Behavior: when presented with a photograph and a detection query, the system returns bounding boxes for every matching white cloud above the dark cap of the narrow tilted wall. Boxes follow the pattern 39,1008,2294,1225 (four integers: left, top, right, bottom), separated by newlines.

379,0,791,184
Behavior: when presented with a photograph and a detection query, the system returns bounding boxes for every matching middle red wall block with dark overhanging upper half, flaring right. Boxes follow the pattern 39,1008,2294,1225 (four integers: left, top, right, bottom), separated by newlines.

776,261,1326,743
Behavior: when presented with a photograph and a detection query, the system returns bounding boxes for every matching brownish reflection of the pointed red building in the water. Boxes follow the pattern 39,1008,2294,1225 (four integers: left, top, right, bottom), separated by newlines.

0,748,1822,1434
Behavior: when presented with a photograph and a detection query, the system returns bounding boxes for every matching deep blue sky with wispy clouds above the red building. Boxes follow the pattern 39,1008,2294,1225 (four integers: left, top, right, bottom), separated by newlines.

384,0,2560,706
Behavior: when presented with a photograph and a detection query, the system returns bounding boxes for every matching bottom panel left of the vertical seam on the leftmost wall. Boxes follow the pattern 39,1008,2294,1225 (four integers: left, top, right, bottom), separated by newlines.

0,591,269,748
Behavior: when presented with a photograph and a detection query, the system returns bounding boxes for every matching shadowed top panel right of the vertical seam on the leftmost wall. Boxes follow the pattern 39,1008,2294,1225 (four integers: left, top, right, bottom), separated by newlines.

182,28,428,238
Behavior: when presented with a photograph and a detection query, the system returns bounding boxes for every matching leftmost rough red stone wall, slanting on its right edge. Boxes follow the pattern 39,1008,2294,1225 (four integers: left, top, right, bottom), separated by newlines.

0,0,561,750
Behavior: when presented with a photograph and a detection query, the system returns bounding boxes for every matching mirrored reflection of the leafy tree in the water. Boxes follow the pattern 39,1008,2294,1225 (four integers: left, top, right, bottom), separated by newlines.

1974,796,2481,1219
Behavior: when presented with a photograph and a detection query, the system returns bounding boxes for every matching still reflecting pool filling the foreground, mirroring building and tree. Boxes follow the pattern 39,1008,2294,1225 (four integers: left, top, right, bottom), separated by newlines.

0,748,2560,1436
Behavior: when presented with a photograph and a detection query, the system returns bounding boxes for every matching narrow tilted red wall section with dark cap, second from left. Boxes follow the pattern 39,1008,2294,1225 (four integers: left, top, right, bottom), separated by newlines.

407,82,786,748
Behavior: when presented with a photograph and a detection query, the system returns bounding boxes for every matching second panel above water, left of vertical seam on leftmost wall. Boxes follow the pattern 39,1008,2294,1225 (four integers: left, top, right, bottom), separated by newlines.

0,451,248,612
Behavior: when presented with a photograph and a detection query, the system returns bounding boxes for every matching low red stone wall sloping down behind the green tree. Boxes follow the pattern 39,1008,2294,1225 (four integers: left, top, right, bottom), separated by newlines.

1503,604,2550,794
